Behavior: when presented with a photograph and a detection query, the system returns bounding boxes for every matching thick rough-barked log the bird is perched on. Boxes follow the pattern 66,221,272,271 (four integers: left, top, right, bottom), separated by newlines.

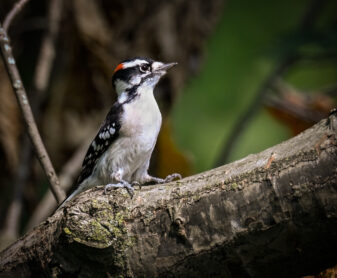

0,115,337,277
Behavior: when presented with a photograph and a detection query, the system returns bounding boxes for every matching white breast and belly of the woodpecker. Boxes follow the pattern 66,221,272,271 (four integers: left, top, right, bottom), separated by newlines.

94,91,162,184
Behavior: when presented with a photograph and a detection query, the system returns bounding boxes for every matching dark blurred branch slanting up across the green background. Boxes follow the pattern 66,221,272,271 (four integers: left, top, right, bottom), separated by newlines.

215,0,326,166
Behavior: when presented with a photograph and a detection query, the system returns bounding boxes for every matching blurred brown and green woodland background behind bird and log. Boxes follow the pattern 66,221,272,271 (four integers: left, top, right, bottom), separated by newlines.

0,0,337,276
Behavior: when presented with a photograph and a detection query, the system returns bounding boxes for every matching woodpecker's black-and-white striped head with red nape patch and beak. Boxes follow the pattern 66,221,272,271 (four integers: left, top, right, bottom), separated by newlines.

112,58,177,100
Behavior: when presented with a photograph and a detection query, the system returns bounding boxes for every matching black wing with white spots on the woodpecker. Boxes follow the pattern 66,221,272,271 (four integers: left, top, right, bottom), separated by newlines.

77,102,123,184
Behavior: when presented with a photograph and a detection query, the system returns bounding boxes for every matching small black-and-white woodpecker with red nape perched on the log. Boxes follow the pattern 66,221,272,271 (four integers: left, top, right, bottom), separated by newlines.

59,57,181,208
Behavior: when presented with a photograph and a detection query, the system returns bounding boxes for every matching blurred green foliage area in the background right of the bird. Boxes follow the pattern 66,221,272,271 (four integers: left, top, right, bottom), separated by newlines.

172,0,337,172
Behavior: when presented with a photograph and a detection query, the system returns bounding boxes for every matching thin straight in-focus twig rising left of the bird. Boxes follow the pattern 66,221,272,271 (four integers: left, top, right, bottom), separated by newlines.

0,25,65,202
